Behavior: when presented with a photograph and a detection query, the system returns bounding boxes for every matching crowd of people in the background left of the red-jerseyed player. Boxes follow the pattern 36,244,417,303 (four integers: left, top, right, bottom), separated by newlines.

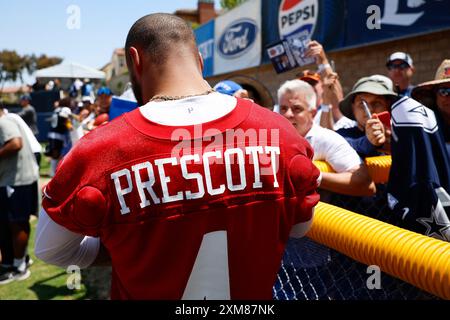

0,79,113,284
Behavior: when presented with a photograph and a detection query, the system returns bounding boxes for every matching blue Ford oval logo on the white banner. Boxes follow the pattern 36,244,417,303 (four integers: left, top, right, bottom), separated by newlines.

217,19,258,59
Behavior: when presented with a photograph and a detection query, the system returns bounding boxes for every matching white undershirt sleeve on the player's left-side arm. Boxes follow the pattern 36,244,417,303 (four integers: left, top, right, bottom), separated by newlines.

34,209,100,269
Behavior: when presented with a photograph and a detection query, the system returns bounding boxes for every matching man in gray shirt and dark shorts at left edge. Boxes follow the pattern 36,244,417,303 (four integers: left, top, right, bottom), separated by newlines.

0,103,39,285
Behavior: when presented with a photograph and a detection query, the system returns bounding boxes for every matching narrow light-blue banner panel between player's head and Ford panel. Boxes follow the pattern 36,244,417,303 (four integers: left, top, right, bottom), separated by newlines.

194,20,215,77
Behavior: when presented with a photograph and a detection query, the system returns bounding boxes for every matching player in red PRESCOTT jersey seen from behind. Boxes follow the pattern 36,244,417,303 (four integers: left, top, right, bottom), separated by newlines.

35,14,319,299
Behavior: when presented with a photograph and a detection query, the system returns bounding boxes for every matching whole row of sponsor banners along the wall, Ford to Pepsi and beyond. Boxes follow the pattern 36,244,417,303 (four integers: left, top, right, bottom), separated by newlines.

195,0,450,77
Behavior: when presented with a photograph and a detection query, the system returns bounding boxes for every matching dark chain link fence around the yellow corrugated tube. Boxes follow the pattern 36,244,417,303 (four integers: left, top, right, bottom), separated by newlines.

273,184,438,300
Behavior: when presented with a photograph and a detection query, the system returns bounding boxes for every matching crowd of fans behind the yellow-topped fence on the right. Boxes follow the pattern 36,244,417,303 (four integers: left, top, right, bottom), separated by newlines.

216,41,450,241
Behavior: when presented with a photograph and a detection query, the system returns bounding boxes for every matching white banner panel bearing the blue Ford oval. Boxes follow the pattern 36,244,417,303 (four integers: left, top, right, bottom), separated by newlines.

214,0,261,74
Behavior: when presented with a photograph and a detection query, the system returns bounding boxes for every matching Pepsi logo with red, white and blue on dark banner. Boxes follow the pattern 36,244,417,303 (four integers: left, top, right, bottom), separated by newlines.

278,0,319,39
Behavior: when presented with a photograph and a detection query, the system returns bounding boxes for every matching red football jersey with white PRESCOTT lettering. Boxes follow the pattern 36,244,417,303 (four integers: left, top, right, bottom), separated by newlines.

43,99,319,299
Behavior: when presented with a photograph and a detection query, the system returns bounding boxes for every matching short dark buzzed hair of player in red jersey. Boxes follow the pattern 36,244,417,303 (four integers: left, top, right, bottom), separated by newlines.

125,13,197,70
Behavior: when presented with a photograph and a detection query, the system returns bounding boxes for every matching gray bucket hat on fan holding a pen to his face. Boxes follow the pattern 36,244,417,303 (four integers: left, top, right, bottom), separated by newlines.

339,74,397,120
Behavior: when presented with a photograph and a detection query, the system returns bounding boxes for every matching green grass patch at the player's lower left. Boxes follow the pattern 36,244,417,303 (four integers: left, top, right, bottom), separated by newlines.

0,215,88,300
